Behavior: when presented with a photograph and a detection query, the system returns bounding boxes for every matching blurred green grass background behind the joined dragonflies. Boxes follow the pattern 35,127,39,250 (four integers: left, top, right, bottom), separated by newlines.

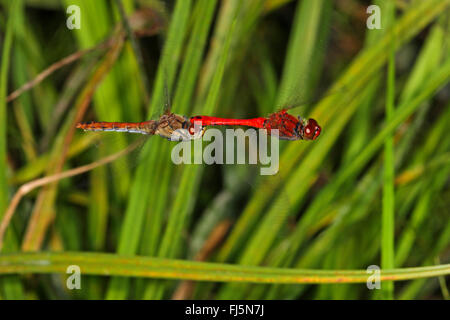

0,0,450,299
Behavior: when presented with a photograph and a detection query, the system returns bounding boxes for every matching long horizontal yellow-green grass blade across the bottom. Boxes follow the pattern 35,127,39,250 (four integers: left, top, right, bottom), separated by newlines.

0,252,450,284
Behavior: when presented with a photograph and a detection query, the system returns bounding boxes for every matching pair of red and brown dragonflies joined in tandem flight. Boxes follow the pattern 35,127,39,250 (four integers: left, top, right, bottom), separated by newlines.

77,109,321,141
